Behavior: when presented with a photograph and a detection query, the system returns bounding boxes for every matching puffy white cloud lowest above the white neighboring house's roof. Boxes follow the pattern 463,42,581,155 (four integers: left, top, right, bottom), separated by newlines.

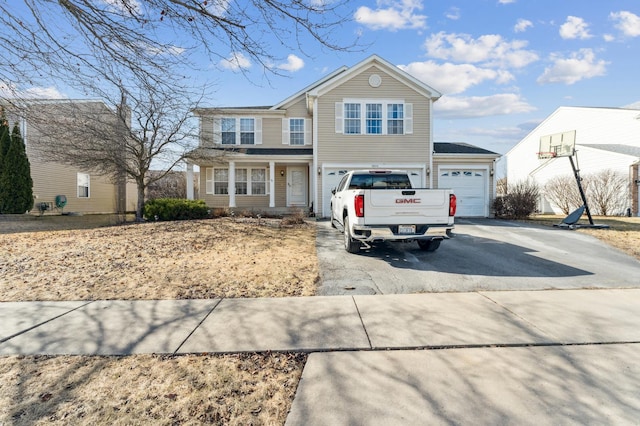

537,49,608,84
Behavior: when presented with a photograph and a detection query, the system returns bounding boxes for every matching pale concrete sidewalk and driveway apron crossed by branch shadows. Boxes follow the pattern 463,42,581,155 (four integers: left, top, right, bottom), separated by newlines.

0,289,640,425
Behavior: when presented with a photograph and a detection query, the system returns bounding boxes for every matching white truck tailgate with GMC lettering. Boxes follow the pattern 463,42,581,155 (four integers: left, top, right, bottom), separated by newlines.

364,189,450,225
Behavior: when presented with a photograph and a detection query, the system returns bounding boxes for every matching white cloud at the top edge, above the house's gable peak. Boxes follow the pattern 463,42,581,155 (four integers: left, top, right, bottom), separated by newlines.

354,0,427,31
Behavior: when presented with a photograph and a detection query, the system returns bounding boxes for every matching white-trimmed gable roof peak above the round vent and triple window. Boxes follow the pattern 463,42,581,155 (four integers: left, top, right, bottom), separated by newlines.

307,55,442,102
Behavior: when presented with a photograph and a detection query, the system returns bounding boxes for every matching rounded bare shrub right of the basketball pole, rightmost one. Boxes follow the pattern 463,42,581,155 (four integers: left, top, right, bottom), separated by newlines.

586,169,629,216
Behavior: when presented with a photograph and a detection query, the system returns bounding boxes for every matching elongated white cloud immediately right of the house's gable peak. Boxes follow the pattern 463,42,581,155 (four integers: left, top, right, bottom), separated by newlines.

398,61,514,95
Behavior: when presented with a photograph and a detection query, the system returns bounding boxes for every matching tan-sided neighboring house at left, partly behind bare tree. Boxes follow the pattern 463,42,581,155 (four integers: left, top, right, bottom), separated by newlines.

6,100,126,214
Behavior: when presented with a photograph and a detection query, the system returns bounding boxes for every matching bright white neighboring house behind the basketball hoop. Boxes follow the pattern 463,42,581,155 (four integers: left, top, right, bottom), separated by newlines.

504,107,640,216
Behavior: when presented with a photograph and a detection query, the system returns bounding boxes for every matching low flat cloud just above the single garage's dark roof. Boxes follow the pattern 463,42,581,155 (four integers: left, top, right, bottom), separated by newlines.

433,93,535,118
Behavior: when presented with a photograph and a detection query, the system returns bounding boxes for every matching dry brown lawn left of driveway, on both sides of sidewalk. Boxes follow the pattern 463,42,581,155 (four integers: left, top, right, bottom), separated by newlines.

0,218,318,425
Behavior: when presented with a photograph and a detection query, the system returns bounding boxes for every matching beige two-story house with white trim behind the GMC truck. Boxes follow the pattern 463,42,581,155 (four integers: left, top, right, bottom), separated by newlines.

187,55,499,217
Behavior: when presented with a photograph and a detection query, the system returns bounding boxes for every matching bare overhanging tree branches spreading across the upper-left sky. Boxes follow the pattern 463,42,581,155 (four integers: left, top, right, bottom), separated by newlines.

0,0,353,97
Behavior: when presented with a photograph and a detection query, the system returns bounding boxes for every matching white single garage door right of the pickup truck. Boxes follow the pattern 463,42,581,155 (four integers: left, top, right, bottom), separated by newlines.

438,169,488,217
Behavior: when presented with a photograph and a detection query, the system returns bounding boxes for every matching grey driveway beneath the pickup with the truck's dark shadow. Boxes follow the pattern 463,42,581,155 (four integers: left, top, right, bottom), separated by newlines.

317,219,640,295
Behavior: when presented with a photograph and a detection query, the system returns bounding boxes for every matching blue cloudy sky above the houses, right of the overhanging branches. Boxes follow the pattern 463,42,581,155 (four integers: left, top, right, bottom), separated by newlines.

199,0,640,154
